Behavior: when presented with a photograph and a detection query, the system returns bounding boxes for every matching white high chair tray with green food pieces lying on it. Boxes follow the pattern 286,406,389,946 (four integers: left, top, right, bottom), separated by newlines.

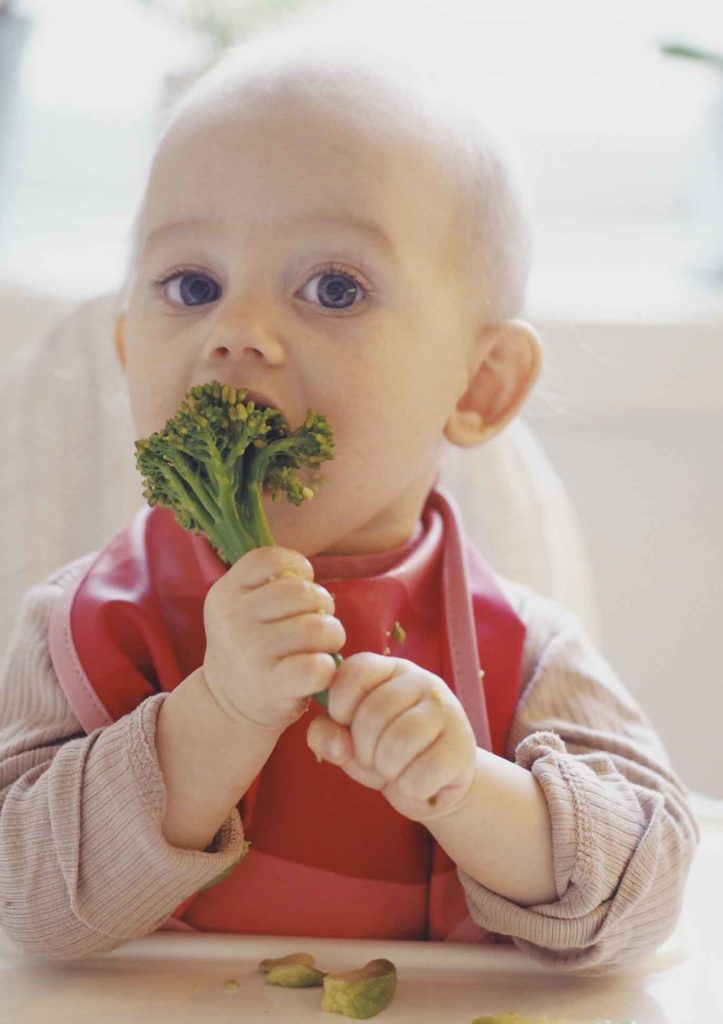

0,926,717,1024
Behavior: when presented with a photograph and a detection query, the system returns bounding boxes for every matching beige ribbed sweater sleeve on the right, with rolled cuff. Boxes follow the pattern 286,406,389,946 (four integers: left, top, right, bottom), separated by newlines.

459,584,698,974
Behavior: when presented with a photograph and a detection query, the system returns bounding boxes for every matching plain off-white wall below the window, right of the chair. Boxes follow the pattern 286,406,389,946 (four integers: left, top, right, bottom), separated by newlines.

527,324,723,797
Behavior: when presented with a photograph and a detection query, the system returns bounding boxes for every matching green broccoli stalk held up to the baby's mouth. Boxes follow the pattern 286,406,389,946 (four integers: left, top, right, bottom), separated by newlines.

135,381,342,707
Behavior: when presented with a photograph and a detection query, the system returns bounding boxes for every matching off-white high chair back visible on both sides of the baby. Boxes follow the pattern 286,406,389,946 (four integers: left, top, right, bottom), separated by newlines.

0,289,597,652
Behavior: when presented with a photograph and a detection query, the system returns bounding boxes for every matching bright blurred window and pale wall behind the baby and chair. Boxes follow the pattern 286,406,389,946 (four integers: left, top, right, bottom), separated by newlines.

0,0,723,797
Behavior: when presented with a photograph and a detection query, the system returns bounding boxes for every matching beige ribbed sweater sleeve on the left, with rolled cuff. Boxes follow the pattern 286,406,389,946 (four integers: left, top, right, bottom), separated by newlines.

0,559,246,959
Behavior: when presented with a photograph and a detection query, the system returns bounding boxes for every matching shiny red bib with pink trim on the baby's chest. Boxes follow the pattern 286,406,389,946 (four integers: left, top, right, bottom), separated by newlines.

50,487,524,942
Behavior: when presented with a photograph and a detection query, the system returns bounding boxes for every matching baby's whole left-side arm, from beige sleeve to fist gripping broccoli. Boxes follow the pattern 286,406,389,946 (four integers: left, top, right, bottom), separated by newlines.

0,546,345,958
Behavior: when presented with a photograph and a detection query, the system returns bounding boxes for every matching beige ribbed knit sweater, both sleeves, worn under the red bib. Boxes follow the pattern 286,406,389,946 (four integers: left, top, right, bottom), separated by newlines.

0,556,697,973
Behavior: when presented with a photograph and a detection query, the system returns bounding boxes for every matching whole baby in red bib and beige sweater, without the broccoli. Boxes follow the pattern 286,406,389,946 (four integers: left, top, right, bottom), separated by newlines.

0,18,696,971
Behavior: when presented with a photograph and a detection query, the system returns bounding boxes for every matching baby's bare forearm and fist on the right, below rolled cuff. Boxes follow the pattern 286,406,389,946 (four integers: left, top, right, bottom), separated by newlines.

307,651,556,905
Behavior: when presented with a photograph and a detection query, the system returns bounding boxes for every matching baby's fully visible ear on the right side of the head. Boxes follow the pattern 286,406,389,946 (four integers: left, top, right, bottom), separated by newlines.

444,319,542,447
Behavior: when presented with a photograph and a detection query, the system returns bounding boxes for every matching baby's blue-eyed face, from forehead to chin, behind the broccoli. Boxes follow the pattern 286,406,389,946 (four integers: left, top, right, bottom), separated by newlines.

121,95,470,555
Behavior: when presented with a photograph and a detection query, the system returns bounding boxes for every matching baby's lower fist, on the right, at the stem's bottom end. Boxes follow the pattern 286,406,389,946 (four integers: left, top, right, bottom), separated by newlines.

306,652,476,821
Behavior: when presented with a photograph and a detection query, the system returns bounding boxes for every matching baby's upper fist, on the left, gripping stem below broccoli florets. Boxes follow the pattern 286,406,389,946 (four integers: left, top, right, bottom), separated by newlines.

204,547,346,732
